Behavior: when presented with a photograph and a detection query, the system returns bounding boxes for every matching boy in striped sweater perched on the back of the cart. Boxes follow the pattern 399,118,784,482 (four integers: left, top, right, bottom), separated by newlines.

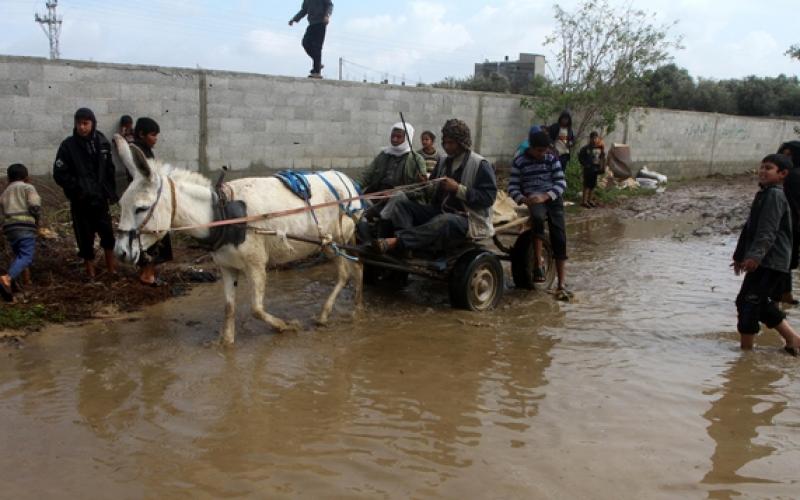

508,132,567,291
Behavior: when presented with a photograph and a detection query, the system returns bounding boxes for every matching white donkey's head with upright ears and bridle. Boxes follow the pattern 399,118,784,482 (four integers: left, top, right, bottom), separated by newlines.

113,134,172,263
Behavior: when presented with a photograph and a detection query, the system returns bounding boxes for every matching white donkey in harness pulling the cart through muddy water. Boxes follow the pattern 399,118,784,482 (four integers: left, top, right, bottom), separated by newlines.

113,135,364,344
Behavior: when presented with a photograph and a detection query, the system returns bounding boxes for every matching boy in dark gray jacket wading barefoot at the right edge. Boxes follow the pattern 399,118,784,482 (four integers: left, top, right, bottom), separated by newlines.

731,154,800,356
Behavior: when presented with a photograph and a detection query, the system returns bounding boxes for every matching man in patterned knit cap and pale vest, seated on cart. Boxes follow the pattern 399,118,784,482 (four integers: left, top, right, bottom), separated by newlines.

373,118,497,253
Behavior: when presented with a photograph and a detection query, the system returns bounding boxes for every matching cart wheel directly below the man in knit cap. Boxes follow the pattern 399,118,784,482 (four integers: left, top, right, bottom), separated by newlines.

450,250,503,311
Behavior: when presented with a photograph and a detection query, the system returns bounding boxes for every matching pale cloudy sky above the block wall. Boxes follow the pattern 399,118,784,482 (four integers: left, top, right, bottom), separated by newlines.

0,0,800,84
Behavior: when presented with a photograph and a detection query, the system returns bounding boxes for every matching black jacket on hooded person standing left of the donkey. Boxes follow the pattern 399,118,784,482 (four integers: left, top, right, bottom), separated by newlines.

53,130,118,206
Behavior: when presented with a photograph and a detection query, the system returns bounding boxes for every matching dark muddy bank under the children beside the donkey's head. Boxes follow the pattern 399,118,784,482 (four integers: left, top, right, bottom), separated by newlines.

0,179,215,337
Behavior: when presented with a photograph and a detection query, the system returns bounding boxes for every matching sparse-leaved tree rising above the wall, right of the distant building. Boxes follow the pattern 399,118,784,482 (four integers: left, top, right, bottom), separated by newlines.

521,0,681,136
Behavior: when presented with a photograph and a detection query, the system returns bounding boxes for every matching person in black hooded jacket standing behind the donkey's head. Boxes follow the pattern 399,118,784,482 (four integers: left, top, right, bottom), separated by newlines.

53,108,118,279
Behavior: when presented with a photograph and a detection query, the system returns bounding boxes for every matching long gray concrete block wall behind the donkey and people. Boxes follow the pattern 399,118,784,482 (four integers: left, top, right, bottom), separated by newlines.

0,56,800,177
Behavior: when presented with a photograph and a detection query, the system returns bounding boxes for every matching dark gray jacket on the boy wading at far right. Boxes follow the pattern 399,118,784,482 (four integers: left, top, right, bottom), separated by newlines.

733,186,792,273
